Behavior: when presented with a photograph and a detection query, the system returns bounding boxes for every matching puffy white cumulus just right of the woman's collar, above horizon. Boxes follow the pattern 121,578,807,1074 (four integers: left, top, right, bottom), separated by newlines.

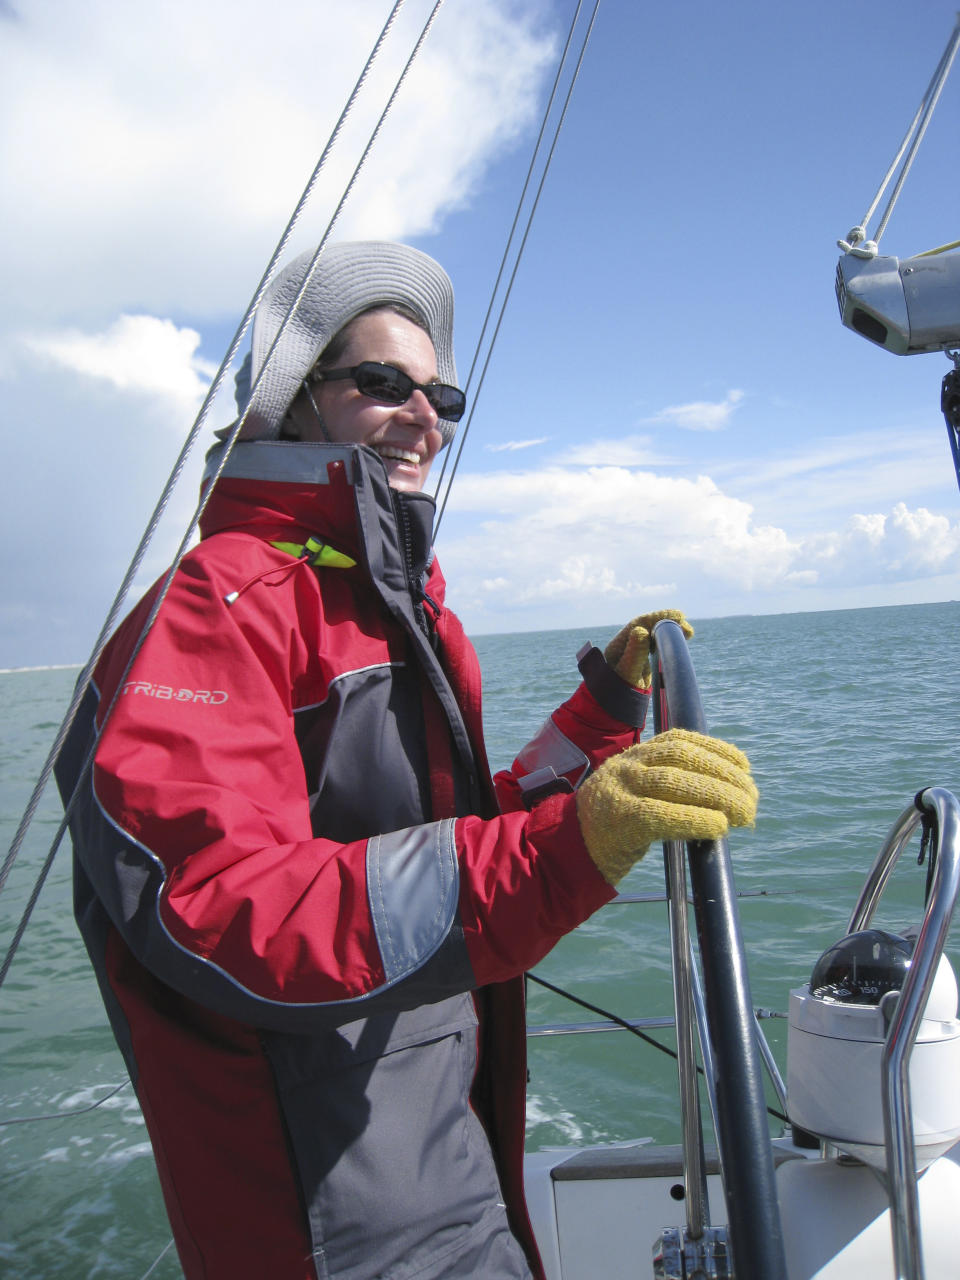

442,466,797,630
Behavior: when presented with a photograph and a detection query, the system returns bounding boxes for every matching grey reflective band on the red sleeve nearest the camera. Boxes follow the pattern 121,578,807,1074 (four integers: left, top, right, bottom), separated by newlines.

366,818,460,983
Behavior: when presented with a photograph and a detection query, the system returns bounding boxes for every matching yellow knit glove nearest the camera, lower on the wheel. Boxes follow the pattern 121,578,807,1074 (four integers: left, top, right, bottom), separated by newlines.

577,728,758,884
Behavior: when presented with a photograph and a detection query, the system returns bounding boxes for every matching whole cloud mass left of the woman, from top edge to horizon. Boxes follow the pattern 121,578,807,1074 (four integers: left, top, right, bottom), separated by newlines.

0,0,554,666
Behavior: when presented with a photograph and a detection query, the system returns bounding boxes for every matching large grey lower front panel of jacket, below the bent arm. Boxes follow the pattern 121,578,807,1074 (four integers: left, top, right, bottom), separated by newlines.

264,996,514,1280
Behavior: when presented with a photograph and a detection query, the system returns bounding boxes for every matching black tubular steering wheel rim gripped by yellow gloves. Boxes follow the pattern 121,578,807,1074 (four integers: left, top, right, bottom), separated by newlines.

653,620,787,1280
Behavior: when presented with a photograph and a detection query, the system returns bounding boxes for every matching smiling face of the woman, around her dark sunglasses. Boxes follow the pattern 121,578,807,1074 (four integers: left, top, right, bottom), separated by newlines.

291,311,443,492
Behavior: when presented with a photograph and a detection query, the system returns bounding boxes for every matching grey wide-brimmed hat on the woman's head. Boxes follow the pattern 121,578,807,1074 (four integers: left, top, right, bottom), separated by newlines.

237,241,457,444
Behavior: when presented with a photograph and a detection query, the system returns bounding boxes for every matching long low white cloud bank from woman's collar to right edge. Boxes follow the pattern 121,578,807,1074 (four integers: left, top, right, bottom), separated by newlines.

440,466,960,631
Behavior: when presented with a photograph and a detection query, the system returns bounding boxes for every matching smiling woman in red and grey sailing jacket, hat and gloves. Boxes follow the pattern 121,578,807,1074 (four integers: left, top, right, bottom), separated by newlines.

60,243,756,1280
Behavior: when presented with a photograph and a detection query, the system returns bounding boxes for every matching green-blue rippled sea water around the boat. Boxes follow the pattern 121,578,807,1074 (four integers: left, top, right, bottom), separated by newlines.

0,603,960,1280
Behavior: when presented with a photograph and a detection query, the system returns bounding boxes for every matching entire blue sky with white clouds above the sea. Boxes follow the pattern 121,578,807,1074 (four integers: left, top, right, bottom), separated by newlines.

0,0,960,668
